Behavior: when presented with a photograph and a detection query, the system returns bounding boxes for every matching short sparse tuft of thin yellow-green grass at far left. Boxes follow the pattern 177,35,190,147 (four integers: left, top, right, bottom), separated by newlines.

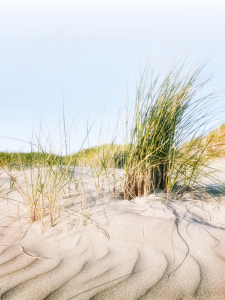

1,133,76,226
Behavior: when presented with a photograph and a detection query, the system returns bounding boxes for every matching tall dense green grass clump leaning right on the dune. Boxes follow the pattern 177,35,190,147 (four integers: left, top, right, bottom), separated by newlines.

123,58,223,199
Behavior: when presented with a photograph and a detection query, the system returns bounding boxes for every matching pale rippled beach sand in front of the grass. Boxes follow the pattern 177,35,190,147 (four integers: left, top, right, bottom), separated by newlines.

0,161,225,300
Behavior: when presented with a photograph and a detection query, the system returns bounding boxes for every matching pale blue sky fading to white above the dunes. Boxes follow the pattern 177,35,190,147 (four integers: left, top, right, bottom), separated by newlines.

0,0,225,151
